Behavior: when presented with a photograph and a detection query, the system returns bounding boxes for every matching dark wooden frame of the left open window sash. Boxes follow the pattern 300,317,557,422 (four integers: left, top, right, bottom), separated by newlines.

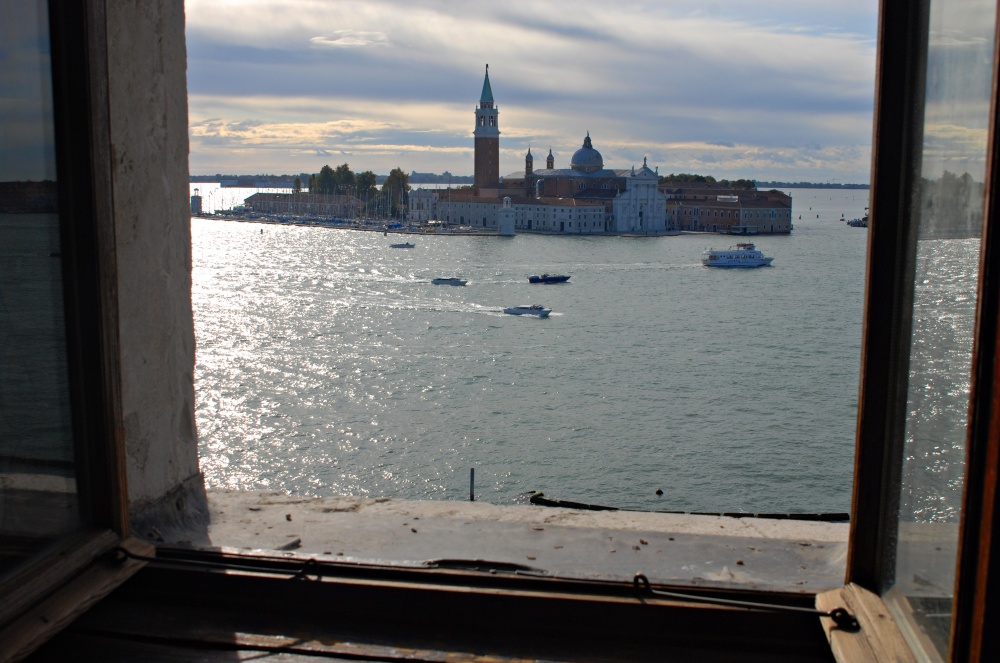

0,0,141,656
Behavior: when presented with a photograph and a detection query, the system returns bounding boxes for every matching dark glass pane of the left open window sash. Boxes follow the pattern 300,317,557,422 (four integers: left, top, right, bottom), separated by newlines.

0,0,80,577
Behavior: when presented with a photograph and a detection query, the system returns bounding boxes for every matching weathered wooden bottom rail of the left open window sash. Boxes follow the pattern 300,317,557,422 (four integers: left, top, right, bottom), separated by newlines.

0,539,156,661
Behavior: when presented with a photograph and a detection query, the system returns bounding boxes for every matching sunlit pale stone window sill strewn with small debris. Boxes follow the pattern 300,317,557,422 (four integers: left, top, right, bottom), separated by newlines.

157,491,848,594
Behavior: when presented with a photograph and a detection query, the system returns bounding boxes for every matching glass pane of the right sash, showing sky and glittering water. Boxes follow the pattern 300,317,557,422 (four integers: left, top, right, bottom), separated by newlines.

889,0,996,655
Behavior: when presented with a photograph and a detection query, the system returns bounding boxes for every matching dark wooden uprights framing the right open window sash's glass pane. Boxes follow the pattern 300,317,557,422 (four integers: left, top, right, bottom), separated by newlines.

846,0,1000,661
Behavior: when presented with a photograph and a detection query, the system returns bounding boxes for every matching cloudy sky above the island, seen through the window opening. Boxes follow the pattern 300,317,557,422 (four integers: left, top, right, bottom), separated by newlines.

185,0,878,183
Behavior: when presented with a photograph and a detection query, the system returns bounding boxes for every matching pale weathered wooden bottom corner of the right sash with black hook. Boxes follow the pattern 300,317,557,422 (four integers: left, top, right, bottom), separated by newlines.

816,583,916,663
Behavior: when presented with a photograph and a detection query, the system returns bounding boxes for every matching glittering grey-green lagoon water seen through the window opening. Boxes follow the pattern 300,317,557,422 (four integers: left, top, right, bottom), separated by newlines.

192,185,868,513
